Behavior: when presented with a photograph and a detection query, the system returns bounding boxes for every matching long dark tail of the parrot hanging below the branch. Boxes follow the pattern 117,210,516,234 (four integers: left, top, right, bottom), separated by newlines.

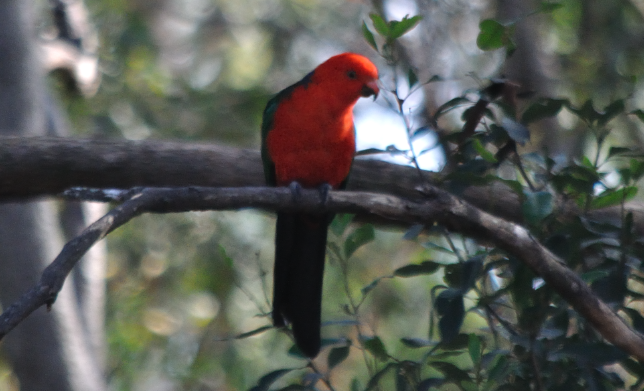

273,212,331,357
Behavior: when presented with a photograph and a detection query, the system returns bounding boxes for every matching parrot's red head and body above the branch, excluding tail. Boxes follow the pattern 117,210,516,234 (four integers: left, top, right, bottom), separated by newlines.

266,53,378,188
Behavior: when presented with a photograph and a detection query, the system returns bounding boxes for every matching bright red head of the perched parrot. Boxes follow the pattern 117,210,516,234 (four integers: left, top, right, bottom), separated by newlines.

313,53,380,102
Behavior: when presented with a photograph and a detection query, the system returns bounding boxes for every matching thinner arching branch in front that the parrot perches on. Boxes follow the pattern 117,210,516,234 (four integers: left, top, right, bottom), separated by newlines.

0,187,644,361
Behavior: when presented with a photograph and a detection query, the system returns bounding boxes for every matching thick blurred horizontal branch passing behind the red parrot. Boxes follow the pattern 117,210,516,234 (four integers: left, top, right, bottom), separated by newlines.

0,137,644,235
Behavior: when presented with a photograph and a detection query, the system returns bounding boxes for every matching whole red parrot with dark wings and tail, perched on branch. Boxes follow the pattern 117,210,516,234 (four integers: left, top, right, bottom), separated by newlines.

262,53,379,357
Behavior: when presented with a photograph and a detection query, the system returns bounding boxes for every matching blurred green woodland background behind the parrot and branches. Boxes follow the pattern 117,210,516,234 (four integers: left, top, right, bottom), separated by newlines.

0,0,644,391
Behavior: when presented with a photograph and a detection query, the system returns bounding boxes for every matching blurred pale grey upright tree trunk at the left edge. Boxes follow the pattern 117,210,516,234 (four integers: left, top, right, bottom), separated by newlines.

0,0,106,391
